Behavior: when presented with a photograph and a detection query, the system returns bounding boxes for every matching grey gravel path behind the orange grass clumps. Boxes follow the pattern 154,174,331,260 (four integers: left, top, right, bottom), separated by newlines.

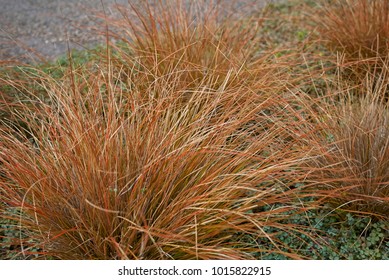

0,0,271,62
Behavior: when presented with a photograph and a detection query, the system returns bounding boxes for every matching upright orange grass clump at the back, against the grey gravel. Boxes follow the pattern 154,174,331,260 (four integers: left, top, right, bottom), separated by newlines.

104,0,281,91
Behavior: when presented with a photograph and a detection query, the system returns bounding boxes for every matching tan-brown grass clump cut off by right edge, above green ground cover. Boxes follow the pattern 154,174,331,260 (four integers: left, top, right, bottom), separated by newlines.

307,71,389,219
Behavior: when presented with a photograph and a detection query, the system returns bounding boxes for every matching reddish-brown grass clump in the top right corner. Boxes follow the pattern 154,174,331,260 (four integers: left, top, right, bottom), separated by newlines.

314,0,389,61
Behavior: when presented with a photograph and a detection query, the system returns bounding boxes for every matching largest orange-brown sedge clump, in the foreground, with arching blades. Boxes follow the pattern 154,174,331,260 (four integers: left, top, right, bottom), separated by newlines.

0,58,310,259
